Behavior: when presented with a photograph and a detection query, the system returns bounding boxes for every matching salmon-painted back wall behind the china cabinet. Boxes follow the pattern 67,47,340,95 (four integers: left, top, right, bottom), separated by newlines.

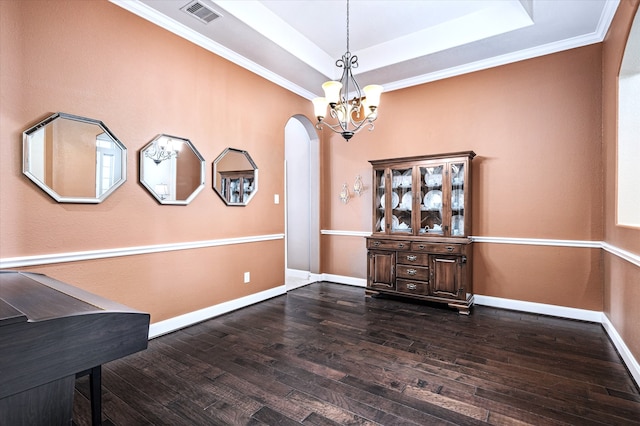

322,44,603,311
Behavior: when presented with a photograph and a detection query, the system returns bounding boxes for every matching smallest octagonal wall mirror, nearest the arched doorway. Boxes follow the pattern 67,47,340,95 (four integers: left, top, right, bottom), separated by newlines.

213,148,258,206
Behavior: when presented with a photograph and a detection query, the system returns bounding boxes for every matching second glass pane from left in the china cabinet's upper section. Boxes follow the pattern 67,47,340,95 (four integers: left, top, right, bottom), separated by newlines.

390,167,414,234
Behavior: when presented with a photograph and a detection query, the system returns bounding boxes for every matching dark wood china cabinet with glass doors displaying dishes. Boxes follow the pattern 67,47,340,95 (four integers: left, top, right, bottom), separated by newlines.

366,151,475,315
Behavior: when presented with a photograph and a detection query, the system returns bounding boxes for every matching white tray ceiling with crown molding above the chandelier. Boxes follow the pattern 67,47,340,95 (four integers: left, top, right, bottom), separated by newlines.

111,0,619,99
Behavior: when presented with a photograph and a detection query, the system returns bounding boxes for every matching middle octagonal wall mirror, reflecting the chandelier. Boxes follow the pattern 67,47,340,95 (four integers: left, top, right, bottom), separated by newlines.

140,134,204,205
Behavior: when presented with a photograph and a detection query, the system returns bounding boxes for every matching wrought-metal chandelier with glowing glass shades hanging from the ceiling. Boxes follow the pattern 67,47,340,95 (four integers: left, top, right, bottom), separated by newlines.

313,0,383,142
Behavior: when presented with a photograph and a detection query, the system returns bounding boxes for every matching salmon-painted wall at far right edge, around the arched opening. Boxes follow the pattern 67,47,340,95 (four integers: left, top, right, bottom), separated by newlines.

602,0,640,360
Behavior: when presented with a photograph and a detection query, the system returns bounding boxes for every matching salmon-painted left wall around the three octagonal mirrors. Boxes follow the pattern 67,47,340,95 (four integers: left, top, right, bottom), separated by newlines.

0,0,312,322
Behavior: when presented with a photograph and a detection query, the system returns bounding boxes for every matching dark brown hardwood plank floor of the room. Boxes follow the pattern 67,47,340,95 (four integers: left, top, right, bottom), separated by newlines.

74,282,640,426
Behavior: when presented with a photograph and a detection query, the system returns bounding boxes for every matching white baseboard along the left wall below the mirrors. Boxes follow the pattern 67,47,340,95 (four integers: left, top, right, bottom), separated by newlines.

149,285,287,339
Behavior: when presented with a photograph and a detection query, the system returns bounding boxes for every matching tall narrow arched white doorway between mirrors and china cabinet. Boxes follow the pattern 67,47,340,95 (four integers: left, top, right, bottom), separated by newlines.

284,115,320,290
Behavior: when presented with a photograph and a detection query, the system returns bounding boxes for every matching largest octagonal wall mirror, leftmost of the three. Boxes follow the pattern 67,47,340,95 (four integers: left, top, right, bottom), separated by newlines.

22,112,127,203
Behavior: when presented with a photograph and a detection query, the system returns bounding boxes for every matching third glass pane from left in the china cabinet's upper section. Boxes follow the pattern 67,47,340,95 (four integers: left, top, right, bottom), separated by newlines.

419,164,445,235
